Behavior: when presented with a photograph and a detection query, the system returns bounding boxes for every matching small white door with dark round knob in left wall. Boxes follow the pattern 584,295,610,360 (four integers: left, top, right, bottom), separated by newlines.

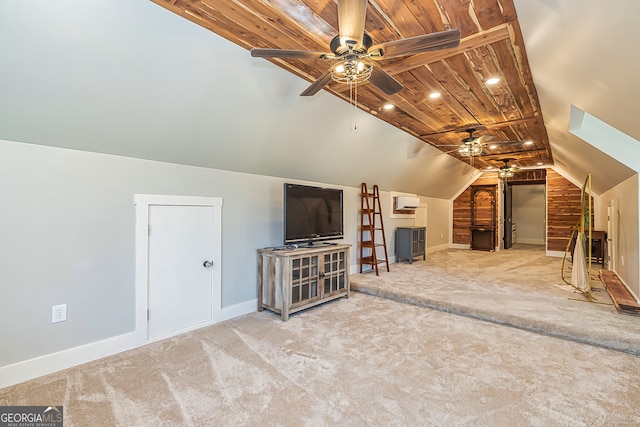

148,205,219,340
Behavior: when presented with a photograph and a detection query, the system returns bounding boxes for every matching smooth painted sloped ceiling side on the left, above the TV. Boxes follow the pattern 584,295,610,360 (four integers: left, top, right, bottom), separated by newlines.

0,0,471,198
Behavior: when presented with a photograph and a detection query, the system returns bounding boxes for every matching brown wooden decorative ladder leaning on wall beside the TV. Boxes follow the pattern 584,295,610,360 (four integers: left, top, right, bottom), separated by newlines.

360,182,389,276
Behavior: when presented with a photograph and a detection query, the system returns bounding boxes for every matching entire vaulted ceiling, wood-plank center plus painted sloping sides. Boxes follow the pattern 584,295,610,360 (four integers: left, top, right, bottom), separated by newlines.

0,0,640,199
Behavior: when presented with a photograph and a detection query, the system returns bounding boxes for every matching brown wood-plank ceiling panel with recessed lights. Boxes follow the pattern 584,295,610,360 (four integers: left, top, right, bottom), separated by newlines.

152,0,553,169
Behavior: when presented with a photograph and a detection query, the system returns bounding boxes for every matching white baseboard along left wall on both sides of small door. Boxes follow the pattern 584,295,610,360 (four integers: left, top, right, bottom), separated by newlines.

0,298,258,388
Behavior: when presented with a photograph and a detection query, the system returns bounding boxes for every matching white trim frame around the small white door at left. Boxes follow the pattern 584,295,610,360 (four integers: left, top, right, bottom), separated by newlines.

134,194,222,345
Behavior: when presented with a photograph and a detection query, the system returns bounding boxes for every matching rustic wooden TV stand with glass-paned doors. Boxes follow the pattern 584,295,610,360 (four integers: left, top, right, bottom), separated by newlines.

258,244,351,321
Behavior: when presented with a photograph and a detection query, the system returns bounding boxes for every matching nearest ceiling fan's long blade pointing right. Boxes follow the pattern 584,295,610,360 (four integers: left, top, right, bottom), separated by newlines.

369,30,460,60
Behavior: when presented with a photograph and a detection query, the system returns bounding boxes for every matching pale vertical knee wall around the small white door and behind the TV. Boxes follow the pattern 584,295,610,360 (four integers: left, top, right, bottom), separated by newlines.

0,140,448,386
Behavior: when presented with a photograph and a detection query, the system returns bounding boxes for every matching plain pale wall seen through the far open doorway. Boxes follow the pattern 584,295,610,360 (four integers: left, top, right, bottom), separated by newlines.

512,184,546,245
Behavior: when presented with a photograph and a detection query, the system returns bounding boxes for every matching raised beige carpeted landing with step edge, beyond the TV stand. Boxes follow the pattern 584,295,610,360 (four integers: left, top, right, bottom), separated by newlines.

351,244,640,355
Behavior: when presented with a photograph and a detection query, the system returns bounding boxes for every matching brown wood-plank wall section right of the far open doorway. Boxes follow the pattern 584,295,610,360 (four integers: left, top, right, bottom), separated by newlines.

547,169,593,252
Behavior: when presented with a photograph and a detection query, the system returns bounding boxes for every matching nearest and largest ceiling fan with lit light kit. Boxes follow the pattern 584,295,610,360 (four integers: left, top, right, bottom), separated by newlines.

251,0,460,96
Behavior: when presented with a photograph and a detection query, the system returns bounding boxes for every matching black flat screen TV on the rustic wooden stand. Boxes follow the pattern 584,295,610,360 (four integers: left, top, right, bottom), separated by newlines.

284,184,344,245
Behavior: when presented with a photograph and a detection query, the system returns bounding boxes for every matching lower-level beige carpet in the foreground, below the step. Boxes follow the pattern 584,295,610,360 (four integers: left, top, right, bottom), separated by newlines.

0,246,640,427
